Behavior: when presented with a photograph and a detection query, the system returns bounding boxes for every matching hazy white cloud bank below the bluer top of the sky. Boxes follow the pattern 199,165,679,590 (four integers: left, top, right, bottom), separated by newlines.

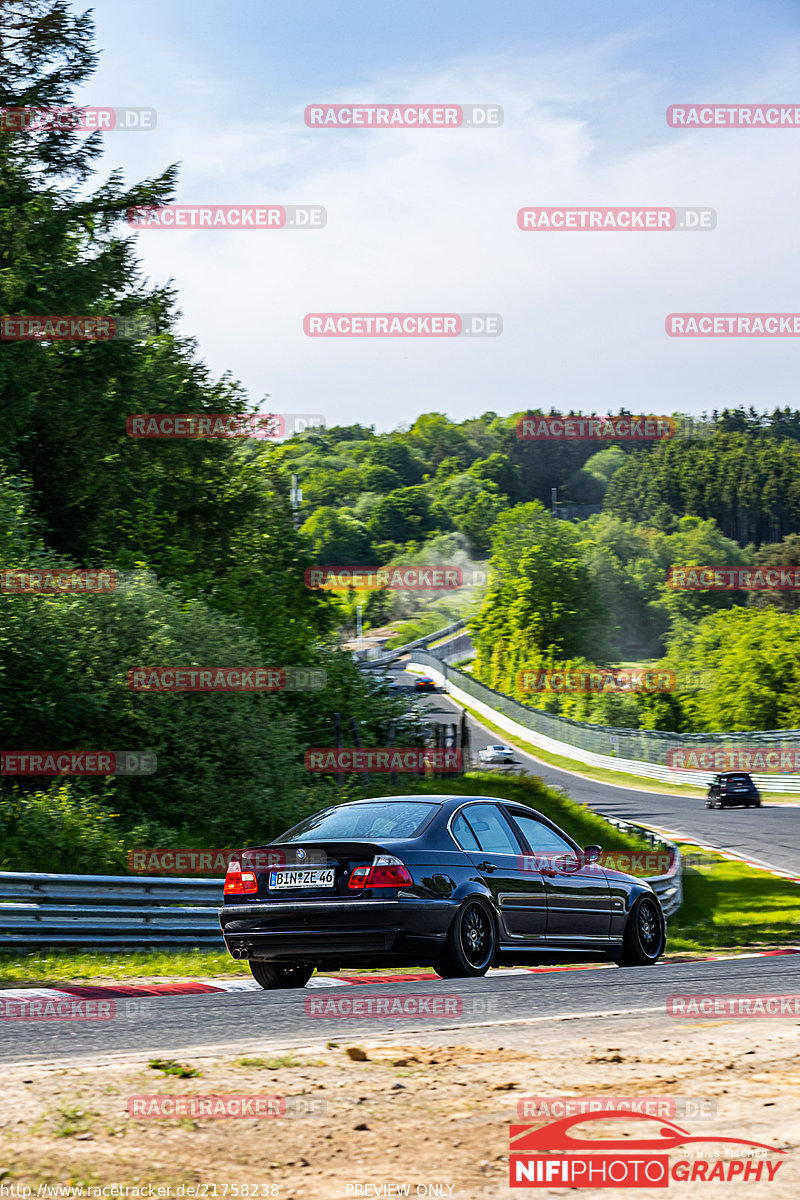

84,40,800,428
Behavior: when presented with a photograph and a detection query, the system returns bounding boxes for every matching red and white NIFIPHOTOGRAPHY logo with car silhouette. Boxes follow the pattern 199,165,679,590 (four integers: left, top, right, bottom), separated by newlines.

509,1109,786,1189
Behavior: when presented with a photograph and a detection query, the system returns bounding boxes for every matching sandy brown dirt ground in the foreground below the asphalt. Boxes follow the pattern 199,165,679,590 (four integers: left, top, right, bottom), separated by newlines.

0,1015,800,1200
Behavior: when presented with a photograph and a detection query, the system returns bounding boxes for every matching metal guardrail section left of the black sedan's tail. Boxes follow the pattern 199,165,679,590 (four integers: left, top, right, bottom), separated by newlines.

0,871,223,950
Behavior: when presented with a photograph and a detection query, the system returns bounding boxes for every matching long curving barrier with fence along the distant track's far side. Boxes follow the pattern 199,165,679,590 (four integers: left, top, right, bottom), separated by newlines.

408,650,800,792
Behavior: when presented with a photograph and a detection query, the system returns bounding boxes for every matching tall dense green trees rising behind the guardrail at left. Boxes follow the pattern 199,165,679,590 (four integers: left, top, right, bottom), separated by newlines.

0,0,422,870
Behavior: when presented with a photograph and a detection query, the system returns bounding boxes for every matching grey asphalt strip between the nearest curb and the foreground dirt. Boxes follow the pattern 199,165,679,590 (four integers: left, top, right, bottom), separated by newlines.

0,954,800,1066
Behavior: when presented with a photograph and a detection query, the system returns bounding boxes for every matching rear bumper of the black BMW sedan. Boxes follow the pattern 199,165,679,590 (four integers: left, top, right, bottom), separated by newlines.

219,899,457,964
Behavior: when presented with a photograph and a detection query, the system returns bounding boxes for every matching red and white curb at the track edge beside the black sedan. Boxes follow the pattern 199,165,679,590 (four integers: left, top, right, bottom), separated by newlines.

0,946,800,1015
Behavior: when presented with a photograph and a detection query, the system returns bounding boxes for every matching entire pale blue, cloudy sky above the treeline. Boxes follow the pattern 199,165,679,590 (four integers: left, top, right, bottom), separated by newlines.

77,0,800,431
